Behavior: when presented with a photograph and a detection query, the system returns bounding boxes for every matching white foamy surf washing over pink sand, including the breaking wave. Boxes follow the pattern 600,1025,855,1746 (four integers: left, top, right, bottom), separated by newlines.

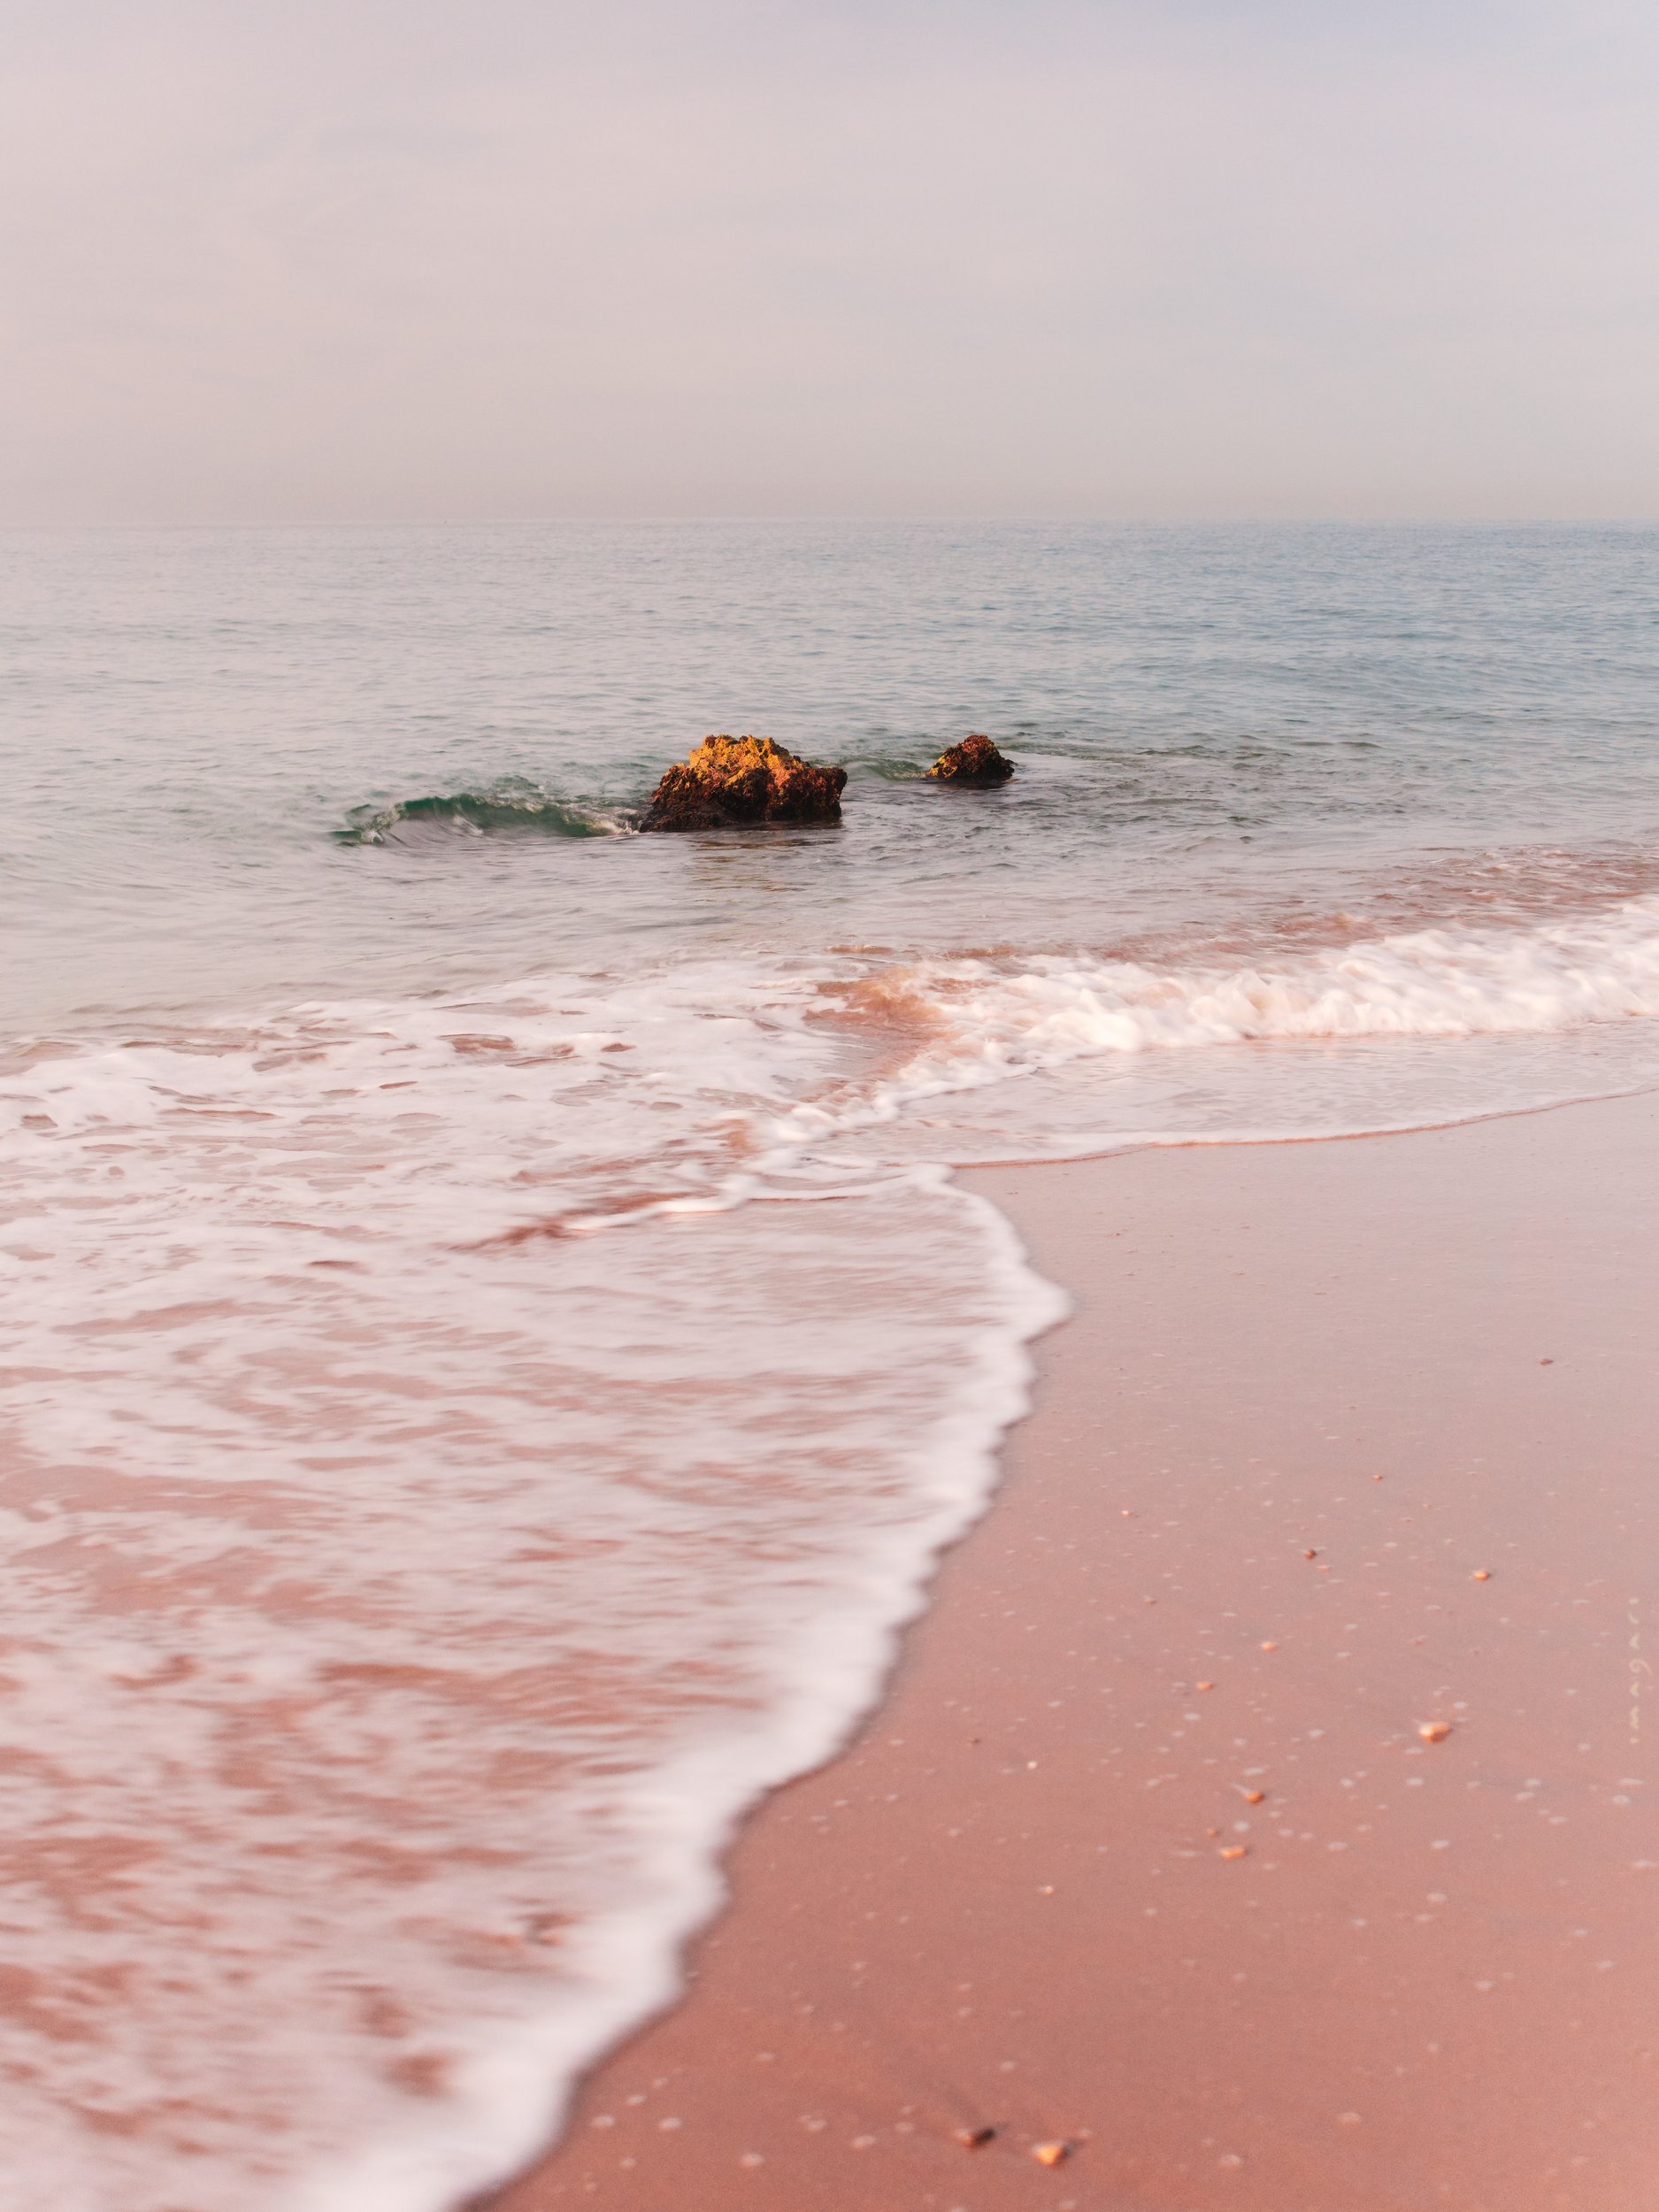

0,901,1659,2212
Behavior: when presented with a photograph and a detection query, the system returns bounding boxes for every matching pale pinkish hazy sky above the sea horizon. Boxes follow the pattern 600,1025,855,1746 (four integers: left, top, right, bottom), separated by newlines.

0,0,1659,522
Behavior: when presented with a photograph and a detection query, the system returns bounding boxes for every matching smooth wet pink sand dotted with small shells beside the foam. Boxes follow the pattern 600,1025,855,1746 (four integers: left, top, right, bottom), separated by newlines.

494,1100,1659,2212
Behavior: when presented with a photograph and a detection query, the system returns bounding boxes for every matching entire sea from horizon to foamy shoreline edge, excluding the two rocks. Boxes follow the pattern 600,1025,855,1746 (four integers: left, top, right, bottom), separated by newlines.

0,525,1659,2212
